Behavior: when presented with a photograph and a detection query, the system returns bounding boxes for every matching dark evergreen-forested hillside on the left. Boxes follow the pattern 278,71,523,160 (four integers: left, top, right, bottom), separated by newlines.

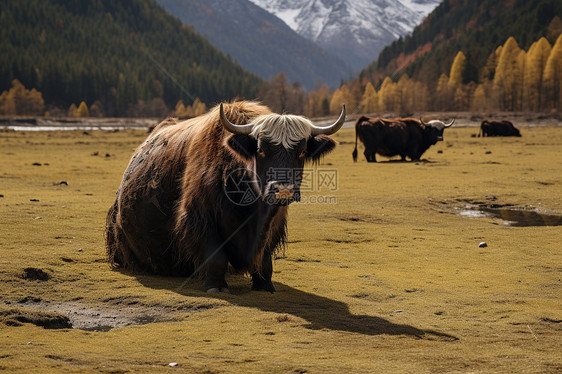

0,0,261,115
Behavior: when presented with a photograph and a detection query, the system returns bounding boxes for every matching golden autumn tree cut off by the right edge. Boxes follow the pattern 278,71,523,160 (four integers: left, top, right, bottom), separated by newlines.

543,35,562,110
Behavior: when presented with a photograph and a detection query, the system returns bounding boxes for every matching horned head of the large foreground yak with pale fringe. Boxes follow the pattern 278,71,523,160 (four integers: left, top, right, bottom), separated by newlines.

220,104,345,205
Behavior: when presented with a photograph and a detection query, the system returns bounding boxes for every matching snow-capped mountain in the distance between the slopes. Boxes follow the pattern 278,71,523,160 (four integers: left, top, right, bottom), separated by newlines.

250,0,440,69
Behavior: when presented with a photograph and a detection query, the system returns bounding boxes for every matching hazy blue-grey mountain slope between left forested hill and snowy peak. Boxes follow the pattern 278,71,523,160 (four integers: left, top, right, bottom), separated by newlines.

158,0,351,89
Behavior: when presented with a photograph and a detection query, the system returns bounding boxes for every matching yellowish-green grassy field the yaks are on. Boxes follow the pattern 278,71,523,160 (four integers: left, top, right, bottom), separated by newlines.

0,127,562,373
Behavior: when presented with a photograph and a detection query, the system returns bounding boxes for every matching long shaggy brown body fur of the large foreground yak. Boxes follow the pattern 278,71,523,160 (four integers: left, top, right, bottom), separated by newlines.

106,101,310,275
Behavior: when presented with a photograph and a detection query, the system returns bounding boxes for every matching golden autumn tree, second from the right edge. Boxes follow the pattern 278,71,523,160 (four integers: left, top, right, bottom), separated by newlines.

523,37,552,111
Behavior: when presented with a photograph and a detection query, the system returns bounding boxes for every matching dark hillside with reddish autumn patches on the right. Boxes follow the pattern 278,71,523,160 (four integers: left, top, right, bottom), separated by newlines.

360,0,562,83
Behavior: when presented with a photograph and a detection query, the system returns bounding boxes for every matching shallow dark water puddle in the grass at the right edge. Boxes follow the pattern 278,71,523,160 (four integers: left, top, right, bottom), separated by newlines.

457,204,562,227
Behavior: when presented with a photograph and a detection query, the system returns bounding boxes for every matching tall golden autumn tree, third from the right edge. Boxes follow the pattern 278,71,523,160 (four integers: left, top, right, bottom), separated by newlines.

494,37,525,111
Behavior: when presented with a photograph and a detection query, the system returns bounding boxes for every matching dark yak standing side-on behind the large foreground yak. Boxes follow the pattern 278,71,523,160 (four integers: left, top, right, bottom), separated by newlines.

353,116,455,162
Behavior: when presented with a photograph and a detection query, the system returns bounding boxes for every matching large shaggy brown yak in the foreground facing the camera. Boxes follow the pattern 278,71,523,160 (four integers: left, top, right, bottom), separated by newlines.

106,101,345,292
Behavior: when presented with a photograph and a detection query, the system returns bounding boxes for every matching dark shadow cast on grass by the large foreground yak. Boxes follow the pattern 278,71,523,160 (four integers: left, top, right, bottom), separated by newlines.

137,275,457,341
